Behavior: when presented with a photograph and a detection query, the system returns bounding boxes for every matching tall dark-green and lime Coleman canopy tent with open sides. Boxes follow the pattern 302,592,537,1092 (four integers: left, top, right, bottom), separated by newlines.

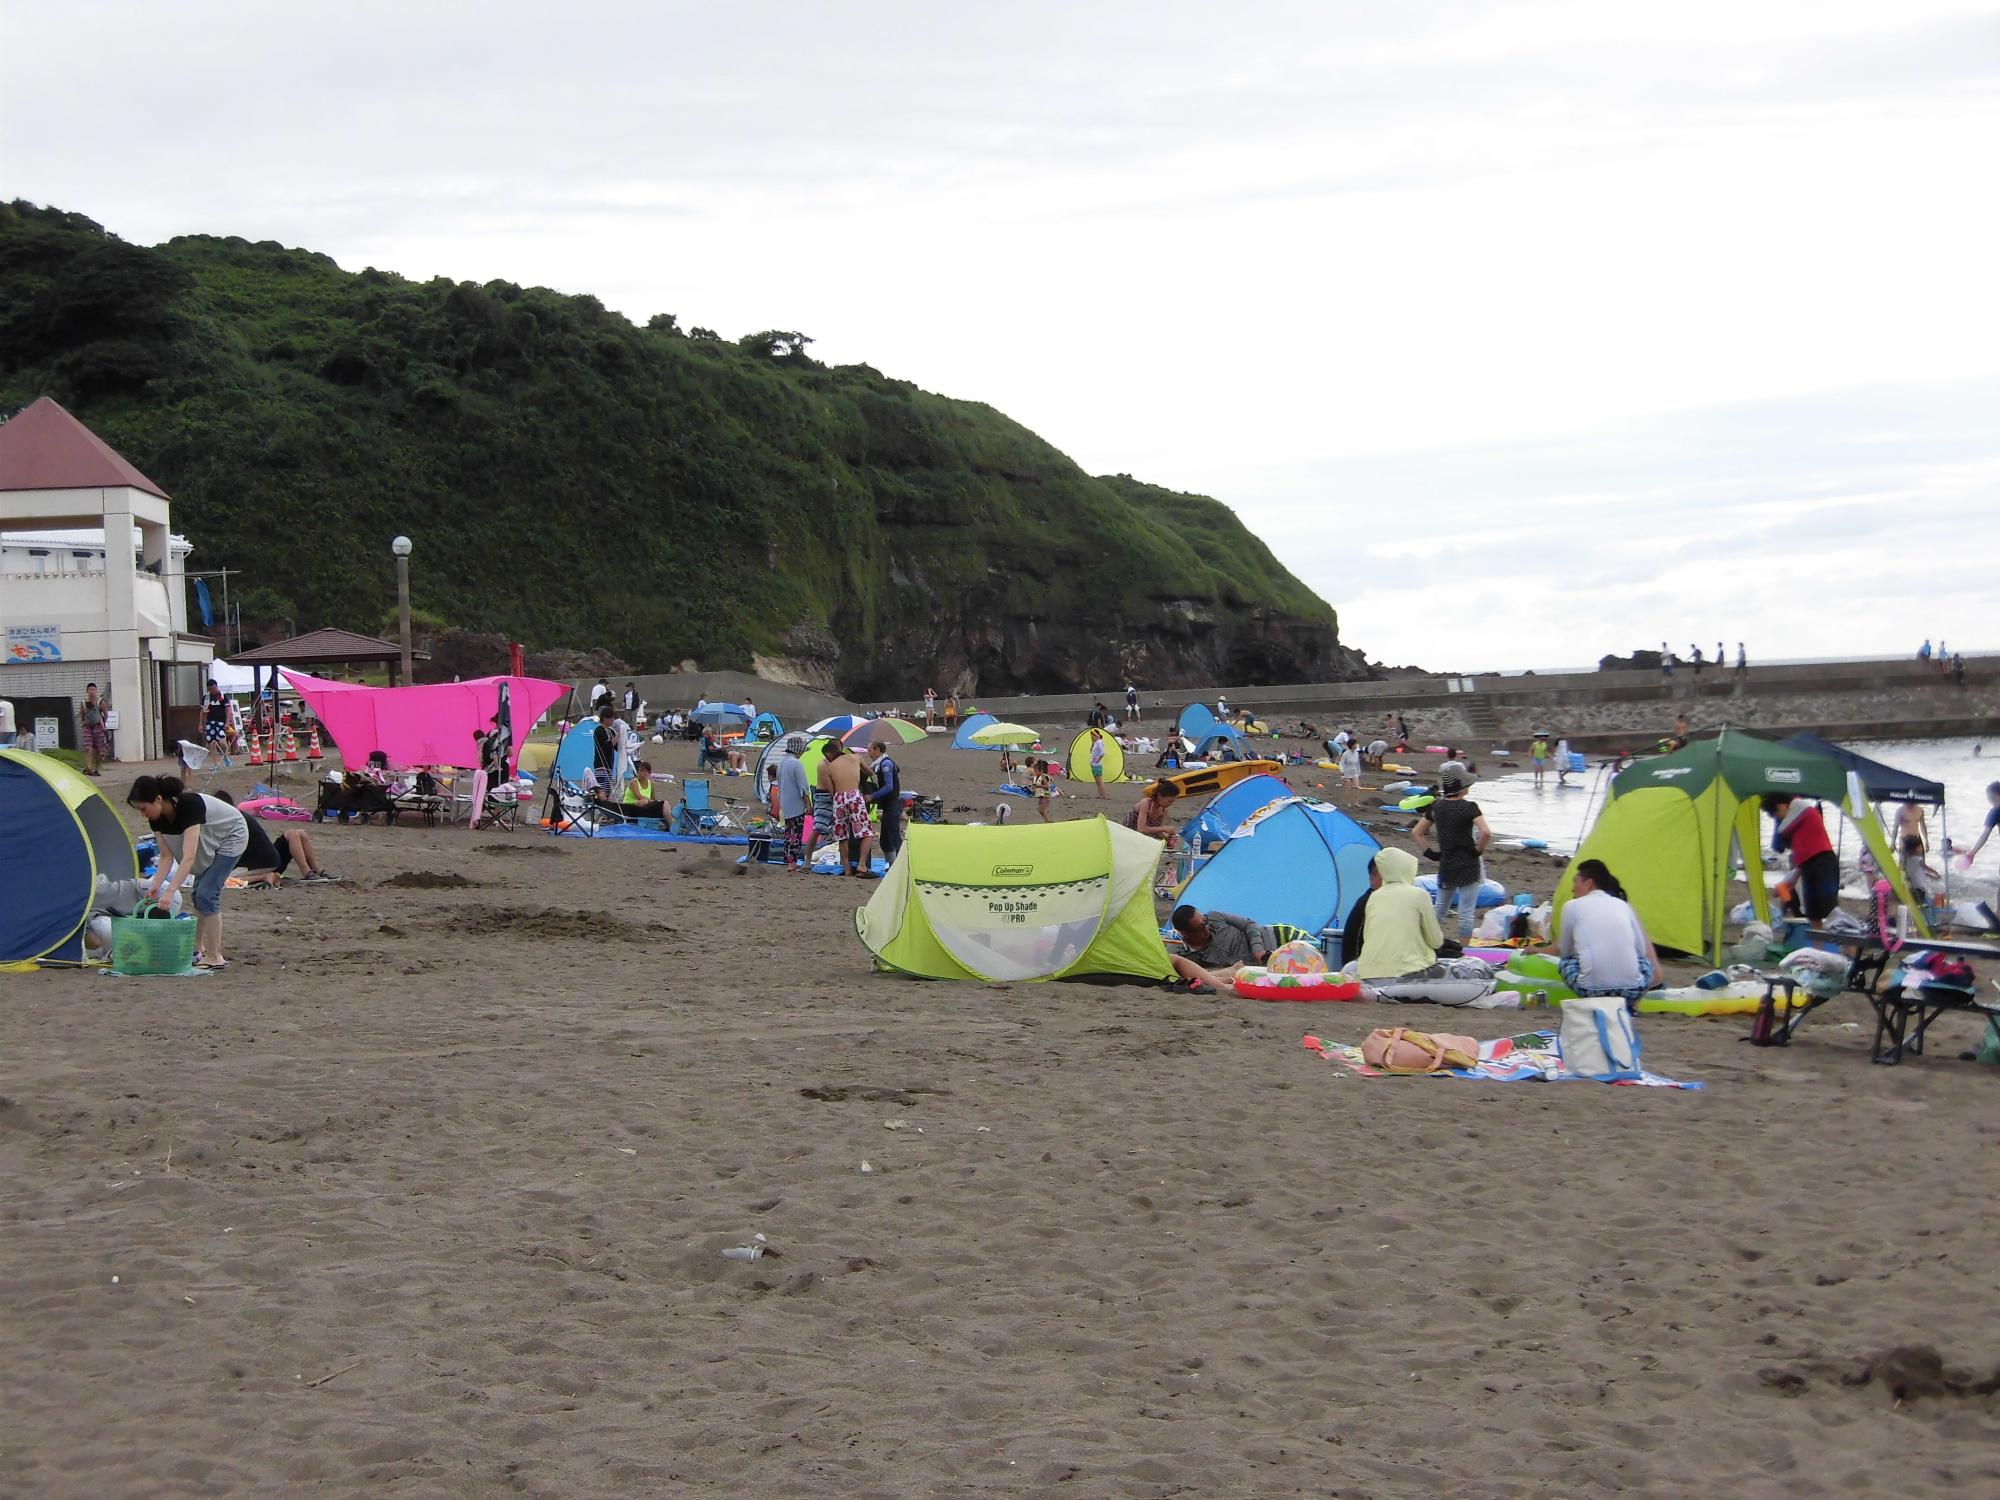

1556,728,1912,964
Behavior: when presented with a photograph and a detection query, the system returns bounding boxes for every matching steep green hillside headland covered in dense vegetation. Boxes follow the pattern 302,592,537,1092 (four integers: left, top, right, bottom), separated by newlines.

0,202,1358,696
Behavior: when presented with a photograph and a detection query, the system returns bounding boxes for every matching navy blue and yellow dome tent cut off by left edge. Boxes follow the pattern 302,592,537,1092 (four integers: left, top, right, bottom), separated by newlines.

0,750,138,964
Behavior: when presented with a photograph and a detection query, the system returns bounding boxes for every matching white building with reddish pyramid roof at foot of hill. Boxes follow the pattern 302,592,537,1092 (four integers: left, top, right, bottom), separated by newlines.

0,396,214,760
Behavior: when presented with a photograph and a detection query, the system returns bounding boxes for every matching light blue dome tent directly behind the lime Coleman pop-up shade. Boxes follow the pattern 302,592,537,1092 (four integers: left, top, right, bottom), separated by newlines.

1180,788,1382,932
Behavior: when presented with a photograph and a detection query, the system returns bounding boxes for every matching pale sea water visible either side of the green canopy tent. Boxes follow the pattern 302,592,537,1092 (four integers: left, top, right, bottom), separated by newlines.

1472,740,2000,898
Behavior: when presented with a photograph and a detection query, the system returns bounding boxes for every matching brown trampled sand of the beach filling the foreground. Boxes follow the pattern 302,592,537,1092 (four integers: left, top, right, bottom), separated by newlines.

0,744,2000,1500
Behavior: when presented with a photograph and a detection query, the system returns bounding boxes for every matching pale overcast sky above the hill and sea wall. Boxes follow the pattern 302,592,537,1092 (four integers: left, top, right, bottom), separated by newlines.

0,0,2000,668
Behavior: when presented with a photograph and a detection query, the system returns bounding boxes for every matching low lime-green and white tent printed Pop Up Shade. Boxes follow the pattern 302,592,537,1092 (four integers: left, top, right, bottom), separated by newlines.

854,818,1174,980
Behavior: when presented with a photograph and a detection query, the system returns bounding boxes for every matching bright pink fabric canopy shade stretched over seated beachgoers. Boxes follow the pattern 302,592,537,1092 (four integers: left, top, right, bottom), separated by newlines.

284,668,570,774
